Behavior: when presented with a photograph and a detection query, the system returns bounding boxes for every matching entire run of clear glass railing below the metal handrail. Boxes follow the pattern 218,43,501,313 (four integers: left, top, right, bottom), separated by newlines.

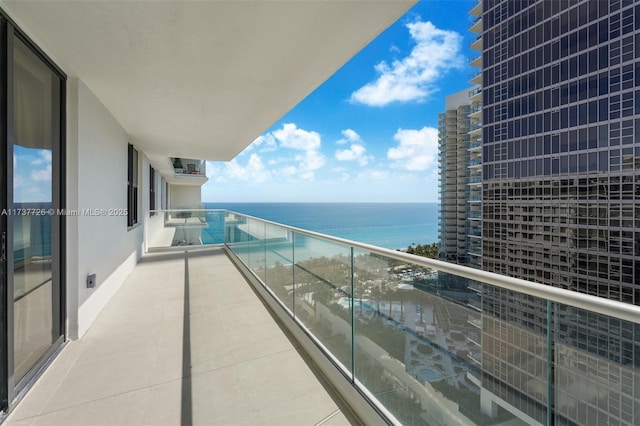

221,211,640,425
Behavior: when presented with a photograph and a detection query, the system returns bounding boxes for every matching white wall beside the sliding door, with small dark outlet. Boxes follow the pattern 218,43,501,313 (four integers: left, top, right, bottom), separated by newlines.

67,79,149,338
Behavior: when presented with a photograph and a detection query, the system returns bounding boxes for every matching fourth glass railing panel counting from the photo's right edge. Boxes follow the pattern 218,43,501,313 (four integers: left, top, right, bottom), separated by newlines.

264,223,293,312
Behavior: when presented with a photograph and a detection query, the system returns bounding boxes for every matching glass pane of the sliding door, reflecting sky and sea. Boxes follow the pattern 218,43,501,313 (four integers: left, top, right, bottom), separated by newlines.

9,39,61,381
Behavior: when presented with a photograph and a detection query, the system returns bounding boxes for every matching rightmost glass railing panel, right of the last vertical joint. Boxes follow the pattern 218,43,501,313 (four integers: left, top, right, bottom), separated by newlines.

553,304,640,425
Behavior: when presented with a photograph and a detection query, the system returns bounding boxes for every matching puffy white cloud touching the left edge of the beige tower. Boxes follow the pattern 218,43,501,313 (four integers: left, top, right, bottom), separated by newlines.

387,127,438,171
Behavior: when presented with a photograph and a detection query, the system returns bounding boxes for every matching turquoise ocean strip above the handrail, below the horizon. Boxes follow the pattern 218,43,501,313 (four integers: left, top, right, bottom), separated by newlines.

204,203,438,249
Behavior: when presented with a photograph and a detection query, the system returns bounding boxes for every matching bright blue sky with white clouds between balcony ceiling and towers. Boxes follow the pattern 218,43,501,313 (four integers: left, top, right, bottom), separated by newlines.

202,0,476,202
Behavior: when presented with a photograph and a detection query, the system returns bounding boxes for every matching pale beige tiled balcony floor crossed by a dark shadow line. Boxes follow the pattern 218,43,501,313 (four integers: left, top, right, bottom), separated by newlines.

5,249,351,425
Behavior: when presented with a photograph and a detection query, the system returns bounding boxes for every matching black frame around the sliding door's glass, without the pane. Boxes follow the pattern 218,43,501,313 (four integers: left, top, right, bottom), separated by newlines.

0,15,67,412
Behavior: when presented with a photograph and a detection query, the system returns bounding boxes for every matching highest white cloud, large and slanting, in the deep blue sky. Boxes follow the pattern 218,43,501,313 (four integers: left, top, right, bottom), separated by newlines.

351,21,464,106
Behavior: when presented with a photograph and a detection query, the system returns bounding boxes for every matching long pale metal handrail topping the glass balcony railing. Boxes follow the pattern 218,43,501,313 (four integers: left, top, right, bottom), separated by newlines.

227,210,640,324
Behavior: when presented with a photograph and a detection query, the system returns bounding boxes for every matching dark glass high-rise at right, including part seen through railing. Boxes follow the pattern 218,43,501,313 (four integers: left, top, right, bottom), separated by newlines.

474,0,640,424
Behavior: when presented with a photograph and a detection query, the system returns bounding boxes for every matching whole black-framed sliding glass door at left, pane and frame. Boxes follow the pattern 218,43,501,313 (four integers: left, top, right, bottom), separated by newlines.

0,21,65,408
